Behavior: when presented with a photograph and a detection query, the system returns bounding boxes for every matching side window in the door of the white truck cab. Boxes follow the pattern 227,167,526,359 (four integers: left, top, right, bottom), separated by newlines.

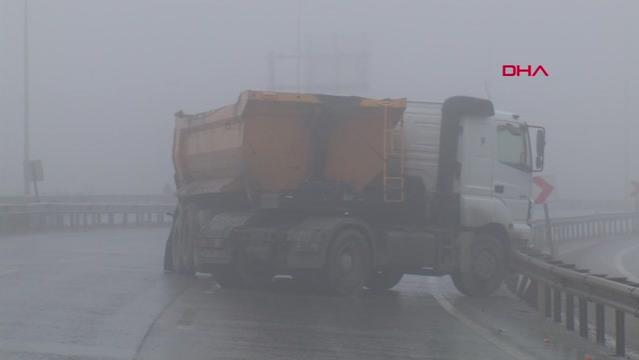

497,124,531,171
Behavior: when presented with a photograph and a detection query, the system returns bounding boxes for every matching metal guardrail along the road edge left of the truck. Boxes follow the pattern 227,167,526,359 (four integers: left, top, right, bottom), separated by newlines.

0,203,175,234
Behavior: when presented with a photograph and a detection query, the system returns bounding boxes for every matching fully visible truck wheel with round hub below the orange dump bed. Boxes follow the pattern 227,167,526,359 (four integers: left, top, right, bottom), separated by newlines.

324,230,370,296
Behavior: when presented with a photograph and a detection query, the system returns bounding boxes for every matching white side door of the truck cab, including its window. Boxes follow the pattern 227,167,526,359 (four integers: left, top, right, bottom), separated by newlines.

493,121,532,224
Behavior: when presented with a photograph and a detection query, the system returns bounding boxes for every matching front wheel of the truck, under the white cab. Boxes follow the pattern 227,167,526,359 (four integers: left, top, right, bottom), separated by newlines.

451,233,506,297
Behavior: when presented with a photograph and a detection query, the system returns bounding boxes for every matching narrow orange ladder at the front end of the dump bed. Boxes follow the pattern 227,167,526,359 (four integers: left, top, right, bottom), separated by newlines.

382,105,405,202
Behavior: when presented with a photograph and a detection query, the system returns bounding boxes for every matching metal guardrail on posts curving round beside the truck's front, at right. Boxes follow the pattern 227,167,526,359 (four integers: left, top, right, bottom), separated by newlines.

511,213,639,356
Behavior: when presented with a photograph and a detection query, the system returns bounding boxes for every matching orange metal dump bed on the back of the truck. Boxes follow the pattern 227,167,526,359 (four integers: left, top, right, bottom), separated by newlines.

173,91,406,195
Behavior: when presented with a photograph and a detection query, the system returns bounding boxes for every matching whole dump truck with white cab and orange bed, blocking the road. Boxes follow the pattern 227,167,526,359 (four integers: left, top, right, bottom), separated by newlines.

164,91,545,296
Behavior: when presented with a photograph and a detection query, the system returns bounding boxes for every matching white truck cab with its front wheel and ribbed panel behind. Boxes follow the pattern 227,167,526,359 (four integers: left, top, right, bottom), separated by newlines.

403,96,545,296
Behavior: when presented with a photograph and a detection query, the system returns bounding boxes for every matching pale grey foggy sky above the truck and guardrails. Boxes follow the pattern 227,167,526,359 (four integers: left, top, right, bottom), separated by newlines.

0,0,639,198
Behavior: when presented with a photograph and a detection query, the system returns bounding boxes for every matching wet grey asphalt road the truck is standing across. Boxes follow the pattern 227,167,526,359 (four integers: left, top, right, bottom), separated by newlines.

0,229,620,360
